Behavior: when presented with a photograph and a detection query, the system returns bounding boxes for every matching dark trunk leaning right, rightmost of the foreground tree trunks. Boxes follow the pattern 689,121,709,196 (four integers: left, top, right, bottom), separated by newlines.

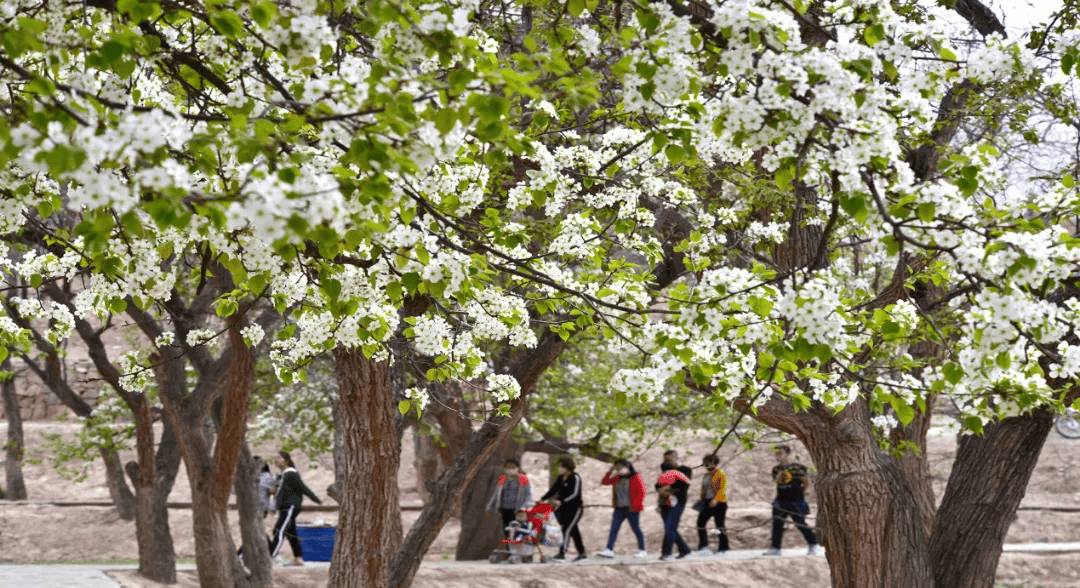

930,411,1054,588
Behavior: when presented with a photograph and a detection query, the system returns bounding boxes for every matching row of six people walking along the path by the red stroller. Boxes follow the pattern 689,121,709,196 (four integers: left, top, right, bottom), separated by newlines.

487,445,818,562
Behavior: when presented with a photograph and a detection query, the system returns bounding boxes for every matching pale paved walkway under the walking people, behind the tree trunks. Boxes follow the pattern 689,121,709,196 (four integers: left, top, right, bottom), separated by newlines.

6,543,1080,588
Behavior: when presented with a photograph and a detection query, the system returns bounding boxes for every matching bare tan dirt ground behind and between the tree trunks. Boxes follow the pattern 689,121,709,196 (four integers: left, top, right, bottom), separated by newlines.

0,423,1080,588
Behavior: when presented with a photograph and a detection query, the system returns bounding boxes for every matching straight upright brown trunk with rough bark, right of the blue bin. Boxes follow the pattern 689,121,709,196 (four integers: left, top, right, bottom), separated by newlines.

329,347,402,588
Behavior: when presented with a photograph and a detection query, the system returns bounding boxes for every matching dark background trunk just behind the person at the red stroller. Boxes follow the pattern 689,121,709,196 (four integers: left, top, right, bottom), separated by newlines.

455,437,524,560
